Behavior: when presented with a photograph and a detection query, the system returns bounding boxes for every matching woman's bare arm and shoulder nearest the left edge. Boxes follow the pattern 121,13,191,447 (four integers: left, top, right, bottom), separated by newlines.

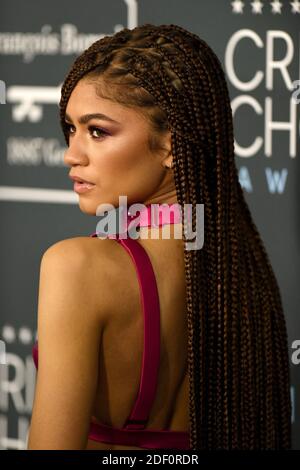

28,239,108,450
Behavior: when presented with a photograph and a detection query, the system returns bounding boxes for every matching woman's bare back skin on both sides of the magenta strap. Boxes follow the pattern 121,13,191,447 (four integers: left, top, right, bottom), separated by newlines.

87,227,189,450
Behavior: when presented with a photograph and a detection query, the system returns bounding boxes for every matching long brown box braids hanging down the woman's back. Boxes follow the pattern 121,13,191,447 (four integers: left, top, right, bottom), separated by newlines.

59,23,291,450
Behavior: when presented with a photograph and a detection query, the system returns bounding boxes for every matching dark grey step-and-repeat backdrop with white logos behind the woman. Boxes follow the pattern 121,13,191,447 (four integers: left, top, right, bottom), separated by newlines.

0,0,300,449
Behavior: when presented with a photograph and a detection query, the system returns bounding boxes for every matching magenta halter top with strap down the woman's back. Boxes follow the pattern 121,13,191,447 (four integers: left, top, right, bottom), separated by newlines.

33,204,190,449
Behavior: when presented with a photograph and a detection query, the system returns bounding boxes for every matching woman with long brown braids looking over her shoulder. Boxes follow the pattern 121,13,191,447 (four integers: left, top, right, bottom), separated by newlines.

28,24,291,450
